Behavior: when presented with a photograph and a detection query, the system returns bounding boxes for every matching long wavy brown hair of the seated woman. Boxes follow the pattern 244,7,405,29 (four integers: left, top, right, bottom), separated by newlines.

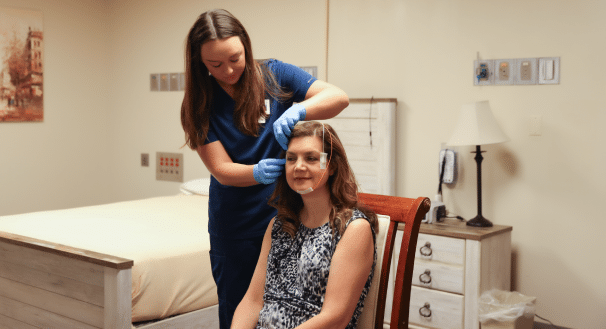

269,121,379,236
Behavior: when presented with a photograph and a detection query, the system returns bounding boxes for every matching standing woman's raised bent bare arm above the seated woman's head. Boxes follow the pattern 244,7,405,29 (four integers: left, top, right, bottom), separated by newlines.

299,80,349,120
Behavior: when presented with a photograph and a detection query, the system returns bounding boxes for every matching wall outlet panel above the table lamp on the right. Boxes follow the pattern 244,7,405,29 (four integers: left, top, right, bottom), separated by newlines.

473,57,560,86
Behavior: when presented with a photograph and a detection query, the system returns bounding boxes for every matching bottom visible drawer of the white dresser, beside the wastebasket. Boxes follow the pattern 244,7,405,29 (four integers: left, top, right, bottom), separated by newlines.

408,286,464,328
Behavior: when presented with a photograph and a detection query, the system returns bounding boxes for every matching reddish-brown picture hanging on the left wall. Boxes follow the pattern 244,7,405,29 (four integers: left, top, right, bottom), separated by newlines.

0,7,44,122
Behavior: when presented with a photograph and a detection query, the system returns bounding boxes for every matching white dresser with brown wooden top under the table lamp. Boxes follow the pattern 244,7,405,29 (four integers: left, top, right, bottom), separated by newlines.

385,220,512,329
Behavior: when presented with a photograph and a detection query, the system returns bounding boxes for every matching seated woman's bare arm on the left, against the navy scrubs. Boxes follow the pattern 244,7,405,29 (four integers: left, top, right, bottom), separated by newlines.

231,219,274,329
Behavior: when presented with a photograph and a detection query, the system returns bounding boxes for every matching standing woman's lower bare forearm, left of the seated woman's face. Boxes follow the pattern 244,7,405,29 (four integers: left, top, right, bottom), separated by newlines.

197,141,259,187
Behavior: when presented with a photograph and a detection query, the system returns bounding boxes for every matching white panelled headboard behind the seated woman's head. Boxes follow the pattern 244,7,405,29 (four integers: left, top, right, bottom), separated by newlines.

323,98,397,196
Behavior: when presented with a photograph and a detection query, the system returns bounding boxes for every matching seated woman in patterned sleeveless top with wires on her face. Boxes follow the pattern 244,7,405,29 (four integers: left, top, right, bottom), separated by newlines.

232,121,378,329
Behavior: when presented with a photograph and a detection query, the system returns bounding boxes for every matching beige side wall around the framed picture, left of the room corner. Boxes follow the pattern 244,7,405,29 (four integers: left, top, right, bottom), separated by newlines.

0,0,111,215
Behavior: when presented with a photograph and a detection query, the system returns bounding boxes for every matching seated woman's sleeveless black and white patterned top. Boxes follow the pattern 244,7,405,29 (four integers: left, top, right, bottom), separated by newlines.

256,209,377,329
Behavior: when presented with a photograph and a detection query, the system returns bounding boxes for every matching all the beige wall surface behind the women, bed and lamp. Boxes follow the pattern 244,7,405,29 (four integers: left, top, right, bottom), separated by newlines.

0,0,606,328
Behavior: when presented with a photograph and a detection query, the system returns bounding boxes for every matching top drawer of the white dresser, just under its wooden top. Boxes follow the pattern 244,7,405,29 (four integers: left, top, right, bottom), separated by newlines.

415,233,465,265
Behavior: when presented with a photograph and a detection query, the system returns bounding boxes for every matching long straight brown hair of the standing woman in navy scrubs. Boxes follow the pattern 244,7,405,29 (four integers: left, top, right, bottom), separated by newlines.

181,9,292,149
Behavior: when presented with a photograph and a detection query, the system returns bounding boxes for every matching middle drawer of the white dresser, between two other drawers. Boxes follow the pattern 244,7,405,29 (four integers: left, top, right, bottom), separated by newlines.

412,259,465,295
